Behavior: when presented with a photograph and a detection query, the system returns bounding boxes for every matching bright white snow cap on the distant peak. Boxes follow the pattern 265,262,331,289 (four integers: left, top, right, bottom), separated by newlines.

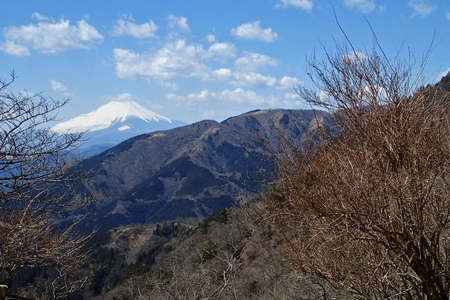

52,101,172,133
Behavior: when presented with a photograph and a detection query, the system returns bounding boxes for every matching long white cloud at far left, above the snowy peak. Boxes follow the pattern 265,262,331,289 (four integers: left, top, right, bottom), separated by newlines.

0,13,103,56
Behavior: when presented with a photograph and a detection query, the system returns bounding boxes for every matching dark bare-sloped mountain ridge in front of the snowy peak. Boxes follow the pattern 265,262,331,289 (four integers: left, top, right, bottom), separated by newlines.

67,110,331,229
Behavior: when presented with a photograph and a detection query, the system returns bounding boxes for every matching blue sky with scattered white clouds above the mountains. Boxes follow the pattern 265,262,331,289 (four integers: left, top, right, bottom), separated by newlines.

0,0,450,122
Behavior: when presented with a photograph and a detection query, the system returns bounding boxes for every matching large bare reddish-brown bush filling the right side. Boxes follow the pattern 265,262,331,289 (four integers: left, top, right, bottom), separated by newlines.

269,44,450,300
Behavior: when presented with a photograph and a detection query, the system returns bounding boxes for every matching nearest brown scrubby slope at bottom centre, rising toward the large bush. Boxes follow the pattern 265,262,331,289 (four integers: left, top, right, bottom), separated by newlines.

95,203,347,300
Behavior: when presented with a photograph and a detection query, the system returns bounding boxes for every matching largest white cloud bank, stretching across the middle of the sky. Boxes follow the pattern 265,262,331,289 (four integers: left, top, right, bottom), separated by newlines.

113,30,300,90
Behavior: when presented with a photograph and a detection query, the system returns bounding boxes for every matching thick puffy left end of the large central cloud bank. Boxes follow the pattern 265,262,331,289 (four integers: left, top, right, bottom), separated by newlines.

113,40,210,80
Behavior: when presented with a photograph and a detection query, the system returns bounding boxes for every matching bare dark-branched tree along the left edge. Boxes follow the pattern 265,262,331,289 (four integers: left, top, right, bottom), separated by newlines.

0,74,87,299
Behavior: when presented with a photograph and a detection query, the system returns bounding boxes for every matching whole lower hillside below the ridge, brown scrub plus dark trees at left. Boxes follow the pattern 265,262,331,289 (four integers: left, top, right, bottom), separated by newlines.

77,200,349,300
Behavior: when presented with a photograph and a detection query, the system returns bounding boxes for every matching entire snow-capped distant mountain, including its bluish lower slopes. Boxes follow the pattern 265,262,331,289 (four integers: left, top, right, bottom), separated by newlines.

52,101,184,156
